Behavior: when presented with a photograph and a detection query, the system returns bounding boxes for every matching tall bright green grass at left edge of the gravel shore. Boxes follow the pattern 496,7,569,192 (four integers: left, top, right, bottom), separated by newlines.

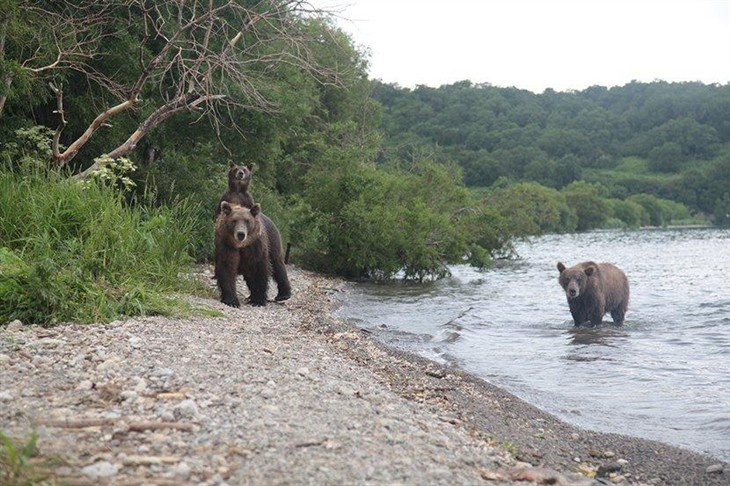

0,171,216,324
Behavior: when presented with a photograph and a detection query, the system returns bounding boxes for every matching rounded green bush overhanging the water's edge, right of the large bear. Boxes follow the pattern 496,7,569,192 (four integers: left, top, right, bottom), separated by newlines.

291,158,508,280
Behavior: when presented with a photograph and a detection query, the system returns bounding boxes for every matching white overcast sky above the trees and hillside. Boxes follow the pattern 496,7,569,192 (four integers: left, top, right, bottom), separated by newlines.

311,0,730,93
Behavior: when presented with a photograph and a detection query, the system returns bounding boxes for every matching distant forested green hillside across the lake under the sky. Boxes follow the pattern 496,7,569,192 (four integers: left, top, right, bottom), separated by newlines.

373,81,730,228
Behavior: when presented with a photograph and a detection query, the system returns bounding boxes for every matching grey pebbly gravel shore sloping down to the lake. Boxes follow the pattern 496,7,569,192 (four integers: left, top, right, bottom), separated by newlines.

0,267,730,485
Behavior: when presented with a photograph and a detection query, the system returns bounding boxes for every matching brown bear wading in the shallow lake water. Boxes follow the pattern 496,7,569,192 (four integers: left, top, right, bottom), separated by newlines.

558,262,629,326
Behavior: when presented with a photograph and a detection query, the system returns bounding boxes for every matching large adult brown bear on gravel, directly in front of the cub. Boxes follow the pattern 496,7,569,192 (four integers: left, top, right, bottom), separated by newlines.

215,201,291,307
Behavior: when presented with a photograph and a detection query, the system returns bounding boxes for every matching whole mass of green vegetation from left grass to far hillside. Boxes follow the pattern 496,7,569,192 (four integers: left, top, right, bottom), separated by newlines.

0,0,730,322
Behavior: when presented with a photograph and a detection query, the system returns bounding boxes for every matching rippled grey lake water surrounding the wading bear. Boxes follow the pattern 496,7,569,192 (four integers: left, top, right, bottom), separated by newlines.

340,229,730,460
